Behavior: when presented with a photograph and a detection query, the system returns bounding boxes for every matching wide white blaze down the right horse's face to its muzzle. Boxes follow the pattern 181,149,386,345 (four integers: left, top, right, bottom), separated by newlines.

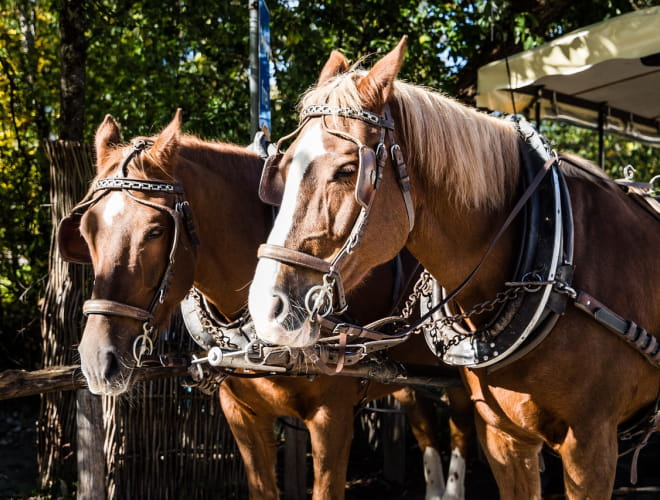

249,124,326,347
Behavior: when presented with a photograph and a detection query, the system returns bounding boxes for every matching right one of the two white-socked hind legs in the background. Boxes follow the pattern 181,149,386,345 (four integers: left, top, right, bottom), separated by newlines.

442,386,474,500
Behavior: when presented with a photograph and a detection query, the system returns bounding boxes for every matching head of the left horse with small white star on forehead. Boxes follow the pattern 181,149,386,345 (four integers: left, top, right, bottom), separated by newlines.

58,111,196,394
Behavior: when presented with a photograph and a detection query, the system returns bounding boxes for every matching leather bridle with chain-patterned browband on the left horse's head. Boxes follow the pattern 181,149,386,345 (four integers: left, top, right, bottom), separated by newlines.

62,140,199,367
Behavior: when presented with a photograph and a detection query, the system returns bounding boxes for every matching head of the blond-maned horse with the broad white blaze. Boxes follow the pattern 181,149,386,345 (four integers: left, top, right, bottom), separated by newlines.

249,37,414,347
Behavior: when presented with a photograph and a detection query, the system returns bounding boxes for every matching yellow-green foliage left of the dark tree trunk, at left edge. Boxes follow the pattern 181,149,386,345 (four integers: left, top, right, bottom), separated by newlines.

0,1,58,367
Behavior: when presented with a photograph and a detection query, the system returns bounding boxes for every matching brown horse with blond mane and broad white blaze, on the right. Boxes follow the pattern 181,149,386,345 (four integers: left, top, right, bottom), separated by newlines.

249,37,660,499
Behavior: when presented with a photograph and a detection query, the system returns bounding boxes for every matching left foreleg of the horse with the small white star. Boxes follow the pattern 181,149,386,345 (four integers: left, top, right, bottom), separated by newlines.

220,380,279,500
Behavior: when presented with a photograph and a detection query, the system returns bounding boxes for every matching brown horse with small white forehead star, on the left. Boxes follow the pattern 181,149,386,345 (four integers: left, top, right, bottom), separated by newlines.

58,112,470,499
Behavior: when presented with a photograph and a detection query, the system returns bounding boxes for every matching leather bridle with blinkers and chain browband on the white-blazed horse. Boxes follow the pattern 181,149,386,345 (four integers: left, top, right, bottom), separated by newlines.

257,104,415,321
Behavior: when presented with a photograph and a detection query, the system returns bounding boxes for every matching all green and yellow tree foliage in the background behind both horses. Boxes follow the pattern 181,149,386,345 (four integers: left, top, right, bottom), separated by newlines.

0,0,658,368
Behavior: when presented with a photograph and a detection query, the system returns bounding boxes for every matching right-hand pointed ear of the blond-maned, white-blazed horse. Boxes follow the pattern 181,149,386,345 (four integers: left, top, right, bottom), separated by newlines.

357,35,408,109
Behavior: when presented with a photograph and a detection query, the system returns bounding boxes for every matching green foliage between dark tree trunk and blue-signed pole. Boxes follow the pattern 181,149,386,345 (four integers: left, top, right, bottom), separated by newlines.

86,0,250,144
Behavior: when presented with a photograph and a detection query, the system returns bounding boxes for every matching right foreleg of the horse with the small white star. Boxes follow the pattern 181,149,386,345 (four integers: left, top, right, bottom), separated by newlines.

305,402,353,500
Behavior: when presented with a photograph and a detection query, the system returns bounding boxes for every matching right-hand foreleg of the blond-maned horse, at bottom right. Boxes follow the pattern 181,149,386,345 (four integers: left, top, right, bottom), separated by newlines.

558,422,618,500
